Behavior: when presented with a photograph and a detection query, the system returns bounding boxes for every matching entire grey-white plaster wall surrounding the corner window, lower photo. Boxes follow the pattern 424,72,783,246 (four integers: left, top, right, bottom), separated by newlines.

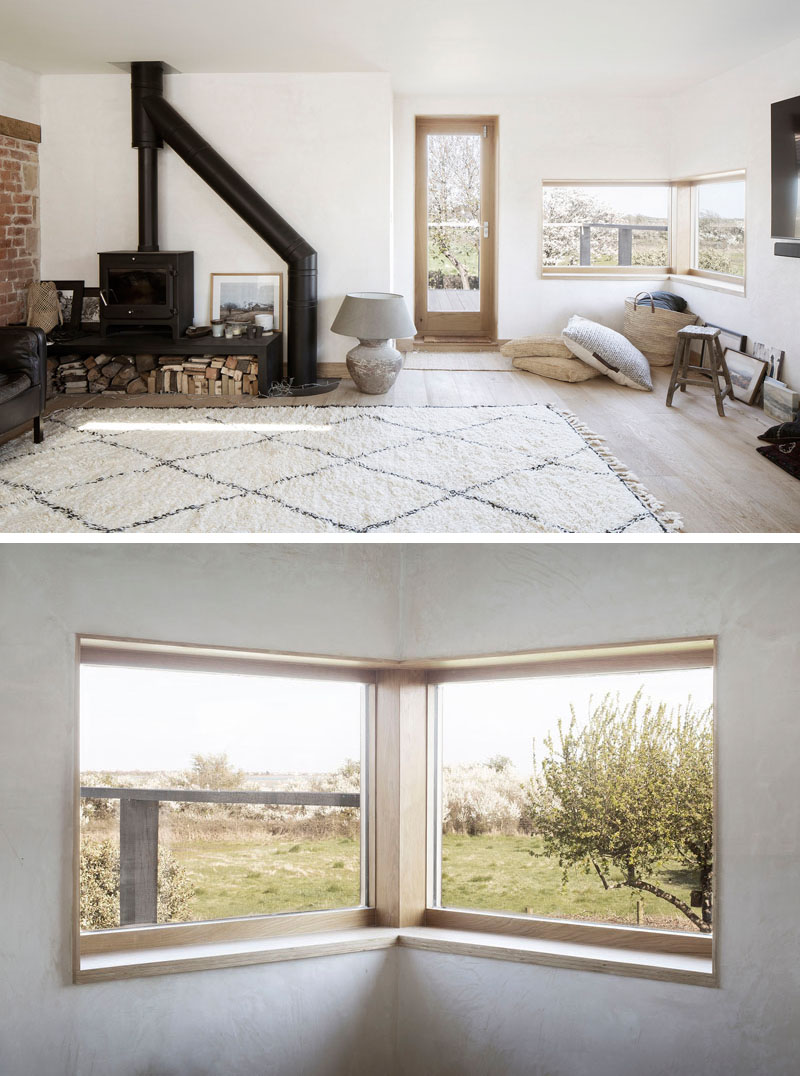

0,543,800,1076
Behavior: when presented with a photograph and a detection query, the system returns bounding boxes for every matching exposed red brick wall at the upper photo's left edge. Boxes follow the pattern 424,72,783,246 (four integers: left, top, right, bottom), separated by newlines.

0,135,39,325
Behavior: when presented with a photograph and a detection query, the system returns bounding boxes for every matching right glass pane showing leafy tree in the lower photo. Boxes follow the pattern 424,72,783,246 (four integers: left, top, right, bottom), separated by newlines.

439,669,713,932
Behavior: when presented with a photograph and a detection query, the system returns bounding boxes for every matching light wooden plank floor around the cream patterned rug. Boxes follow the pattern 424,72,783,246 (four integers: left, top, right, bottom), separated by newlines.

23,369,800,533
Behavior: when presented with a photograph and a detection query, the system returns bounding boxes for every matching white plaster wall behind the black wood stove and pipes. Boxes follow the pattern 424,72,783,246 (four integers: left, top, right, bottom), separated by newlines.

41,73,392,362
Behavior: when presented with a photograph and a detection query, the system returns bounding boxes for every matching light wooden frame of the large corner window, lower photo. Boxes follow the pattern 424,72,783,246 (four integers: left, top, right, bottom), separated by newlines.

72,635,719,986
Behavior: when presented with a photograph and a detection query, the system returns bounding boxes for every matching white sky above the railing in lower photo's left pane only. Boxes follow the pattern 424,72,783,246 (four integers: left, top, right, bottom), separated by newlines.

81,665,363,774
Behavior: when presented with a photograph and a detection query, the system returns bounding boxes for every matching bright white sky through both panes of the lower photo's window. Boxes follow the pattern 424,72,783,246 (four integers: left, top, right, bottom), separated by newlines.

81,665,713,774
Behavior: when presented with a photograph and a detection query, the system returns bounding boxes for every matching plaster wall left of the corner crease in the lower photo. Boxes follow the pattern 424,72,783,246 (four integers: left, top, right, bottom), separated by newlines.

0,543,397,1076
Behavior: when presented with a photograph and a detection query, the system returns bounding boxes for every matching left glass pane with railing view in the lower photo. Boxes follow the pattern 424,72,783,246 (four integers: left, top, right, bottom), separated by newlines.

81,665,365,930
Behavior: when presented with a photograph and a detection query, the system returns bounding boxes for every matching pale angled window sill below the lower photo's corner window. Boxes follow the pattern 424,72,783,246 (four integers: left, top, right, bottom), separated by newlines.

74,926,717,987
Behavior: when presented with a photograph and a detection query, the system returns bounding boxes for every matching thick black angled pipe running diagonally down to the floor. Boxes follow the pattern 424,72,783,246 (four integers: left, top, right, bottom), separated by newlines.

138,74,320,387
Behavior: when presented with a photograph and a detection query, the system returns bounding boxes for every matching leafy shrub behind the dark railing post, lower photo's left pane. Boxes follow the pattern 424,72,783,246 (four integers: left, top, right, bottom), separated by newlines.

81,840,194,931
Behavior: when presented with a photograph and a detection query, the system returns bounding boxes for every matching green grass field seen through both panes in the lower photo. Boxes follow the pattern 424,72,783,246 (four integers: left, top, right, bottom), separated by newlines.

150,835,693,930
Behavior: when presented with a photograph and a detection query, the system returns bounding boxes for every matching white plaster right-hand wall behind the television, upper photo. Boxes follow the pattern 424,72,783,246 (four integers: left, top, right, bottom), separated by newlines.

672,41,800,388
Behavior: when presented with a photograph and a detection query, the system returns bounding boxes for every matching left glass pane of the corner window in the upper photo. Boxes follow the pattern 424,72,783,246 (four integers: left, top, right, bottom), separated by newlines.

542,185,670,268
